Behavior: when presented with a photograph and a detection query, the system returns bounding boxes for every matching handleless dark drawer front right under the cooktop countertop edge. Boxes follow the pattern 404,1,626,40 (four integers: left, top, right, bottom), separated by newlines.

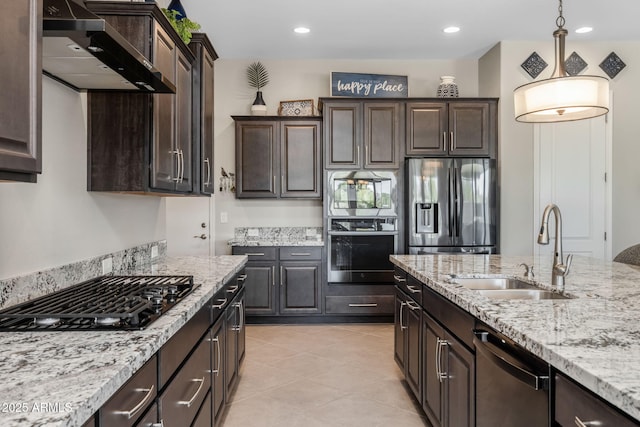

158,305,211,388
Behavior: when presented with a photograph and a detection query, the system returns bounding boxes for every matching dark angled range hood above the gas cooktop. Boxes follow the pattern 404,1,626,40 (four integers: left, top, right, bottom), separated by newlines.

42,0,176,93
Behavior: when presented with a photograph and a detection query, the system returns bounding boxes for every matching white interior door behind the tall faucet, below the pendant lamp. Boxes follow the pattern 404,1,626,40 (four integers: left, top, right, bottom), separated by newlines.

533,113,611,260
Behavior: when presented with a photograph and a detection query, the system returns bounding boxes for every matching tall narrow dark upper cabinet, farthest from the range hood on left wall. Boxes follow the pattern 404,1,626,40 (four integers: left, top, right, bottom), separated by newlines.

189,33,218,195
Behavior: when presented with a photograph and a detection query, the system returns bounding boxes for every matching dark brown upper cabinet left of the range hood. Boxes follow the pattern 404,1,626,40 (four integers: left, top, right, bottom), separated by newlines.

0,0,42,182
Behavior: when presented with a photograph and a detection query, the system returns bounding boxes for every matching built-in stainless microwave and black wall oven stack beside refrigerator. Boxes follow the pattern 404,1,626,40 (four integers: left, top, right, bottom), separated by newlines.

326,171,398,284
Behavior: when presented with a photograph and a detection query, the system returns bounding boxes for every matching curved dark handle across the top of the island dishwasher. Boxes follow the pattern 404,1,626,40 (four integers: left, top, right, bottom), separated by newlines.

473,330,549,390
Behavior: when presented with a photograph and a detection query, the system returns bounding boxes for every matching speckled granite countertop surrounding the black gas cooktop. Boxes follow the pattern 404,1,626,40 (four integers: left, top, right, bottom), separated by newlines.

0,256,247,427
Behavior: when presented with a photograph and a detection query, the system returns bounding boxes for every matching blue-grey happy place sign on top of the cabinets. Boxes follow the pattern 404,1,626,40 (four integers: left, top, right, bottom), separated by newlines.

331,72,409,98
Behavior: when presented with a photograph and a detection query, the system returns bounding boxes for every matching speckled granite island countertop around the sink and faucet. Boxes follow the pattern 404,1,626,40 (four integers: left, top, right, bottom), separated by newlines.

391,255,640,420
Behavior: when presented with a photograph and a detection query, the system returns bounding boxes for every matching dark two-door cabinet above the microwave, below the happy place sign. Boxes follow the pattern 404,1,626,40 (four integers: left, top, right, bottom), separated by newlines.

322,99,403,169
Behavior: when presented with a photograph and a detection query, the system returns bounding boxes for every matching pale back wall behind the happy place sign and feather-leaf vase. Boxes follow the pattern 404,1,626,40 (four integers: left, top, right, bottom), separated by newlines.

212,58,478,255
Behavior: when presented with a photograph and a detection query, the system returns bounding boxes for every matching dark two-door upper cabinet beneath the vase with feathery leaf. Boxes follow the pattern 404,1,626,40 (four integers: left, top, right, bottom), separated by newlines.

233,116,322,199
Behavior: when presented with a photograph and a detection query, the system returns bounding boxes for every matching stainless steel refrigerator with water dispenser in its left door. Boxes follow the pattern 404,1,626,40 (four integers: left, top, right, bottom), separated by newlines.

405,158,498,254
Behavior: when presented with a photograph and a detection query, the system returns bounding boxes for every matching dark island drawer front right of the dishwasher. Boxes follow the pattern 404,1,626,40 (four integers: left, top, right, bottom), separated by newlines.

555,374,640,427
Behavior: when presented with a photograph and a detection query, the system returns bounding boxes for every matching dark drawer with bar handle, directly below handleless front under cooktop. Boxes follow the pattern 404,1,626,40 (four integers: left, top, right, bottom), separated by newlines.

160,335,211,427
